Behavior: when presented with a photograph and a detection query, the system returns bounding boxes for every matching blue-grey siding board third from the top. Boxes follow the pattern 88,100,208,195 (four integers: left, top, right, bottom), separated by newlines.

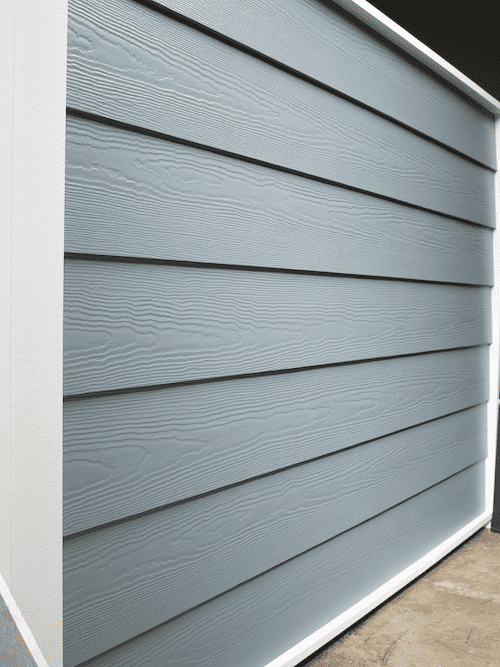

64,116,493,285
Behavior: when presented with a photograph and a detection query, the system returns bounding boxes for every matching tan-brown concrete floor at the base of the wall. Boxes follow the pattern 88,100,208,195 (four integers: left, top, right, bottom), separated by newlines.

300,528,500,667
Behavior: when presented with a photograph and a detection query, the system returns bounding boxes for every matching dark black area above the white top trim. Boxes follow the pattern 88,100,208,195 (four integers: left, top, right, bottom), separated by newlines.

369,0,500,100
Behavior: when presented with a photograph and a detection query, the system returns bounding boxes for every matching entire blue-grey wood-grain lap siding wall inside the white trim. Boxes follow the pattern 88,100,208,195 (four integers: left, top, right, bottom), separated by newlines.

63,0,496,667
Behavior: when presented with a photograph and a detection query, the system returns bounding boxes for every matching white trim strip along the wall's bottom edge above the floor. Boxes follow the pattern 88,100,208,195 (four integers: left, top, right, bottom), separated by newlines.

266,512,492,667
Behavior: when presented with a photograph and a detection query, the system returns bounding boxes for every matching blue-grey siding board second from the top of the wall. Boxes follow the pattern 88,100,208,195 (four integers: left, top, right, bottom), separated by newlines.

67,0,495,227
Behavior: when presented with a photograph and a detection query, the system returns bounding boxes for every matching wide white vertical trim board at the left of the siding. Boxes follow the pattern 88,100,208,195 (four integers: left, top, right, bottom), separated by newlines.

0,0,68,667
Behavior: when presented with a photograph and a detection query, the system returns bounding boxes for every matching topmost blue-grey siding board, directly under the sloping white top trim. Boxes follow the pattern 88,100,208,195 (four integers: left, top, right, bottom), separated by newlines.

147,0,496,169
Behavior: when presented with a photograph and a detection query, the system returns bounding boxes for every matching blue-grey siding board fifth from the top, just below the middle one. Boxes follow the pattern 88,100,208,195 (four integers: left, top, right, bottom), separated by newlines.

63,346,488,535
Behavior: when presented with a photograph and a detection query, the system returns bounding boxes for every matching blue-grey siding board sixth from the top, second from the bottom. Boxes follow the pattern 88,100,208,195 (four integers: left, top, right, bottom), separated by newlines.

64,406,487,650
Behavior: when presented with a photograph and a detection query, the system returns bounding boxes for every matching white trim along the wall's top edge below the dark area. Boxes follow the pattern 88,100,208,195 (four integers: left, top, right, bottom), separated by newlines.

335,0,500,118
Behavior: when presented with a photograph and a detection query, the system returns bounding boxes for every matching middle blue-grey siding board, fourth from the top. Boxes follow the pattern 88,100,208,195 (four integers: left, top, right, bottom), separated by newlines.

64,260,491,395
